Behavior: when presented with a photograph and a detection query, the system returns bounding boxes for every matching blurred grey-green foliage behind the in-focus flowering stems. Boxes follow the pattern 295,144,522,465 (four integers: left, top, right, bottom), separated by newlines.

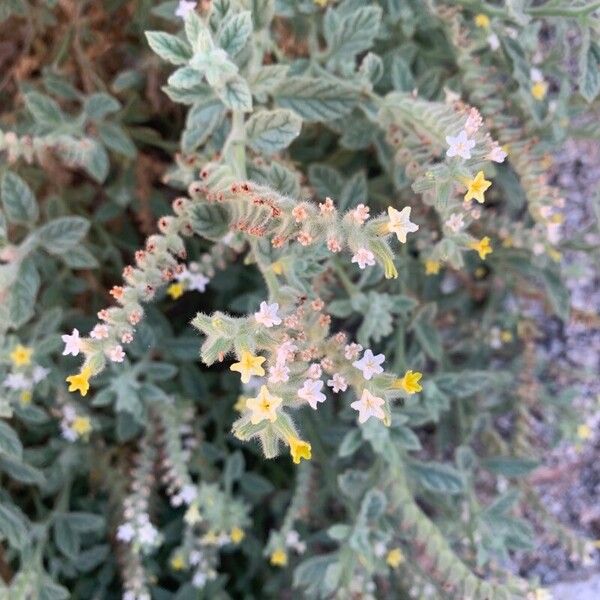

0,0,600,600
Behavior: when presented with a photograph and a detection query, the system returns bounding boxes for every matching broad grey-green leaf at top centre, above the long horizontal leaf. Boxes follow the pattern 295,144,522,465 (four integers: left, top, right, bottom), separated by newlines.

324,6,382,61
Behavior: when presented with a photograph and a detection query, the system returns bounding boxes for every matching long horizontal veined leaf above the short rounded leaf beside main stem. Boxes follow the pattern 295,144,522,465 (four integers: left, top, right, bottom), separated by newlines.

273,77,359,122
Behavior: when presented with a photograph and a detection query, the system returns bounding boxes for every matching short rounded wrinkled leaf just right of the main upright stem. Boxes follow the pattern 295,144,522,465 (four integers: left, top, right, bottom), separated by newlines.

246,109,302,154
